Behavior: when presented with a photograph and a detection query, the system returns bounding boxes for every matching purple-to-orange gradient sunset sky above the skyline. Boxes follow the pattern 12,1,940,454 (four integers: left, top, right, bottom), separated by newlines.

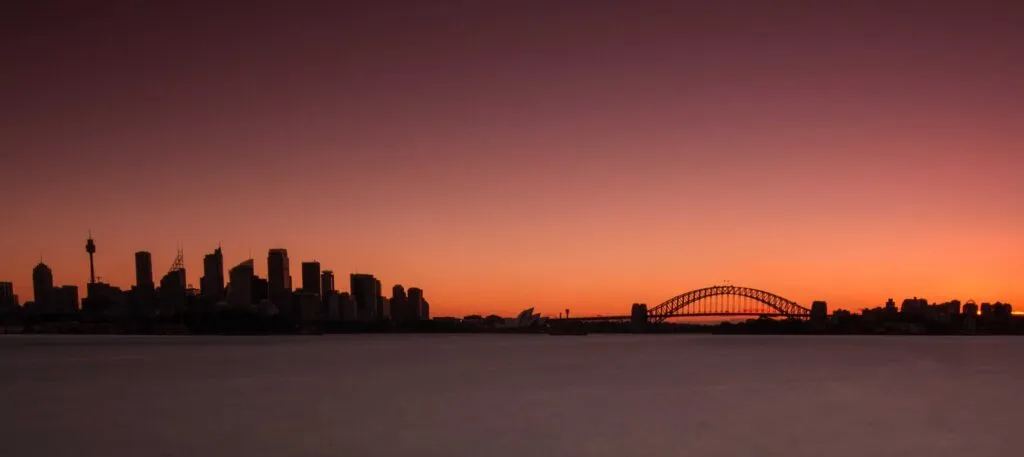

0,0,1024,316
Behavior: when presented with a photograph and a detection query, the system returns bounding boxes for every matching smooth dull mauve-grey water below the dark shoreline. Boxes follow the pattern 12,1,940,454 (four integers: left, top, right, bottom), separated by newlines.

0,335,1024,457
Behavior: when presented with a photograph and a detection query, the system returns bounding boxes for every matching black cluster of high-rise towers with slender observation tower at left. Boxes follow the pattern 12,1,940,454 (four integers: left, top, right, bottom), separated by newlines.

0,238,430,323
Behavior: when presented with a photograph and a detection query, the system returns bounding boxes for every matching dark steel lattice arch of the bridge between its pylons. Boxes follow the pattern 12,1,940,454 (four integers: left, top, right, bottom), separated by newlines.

647,285,811,323
